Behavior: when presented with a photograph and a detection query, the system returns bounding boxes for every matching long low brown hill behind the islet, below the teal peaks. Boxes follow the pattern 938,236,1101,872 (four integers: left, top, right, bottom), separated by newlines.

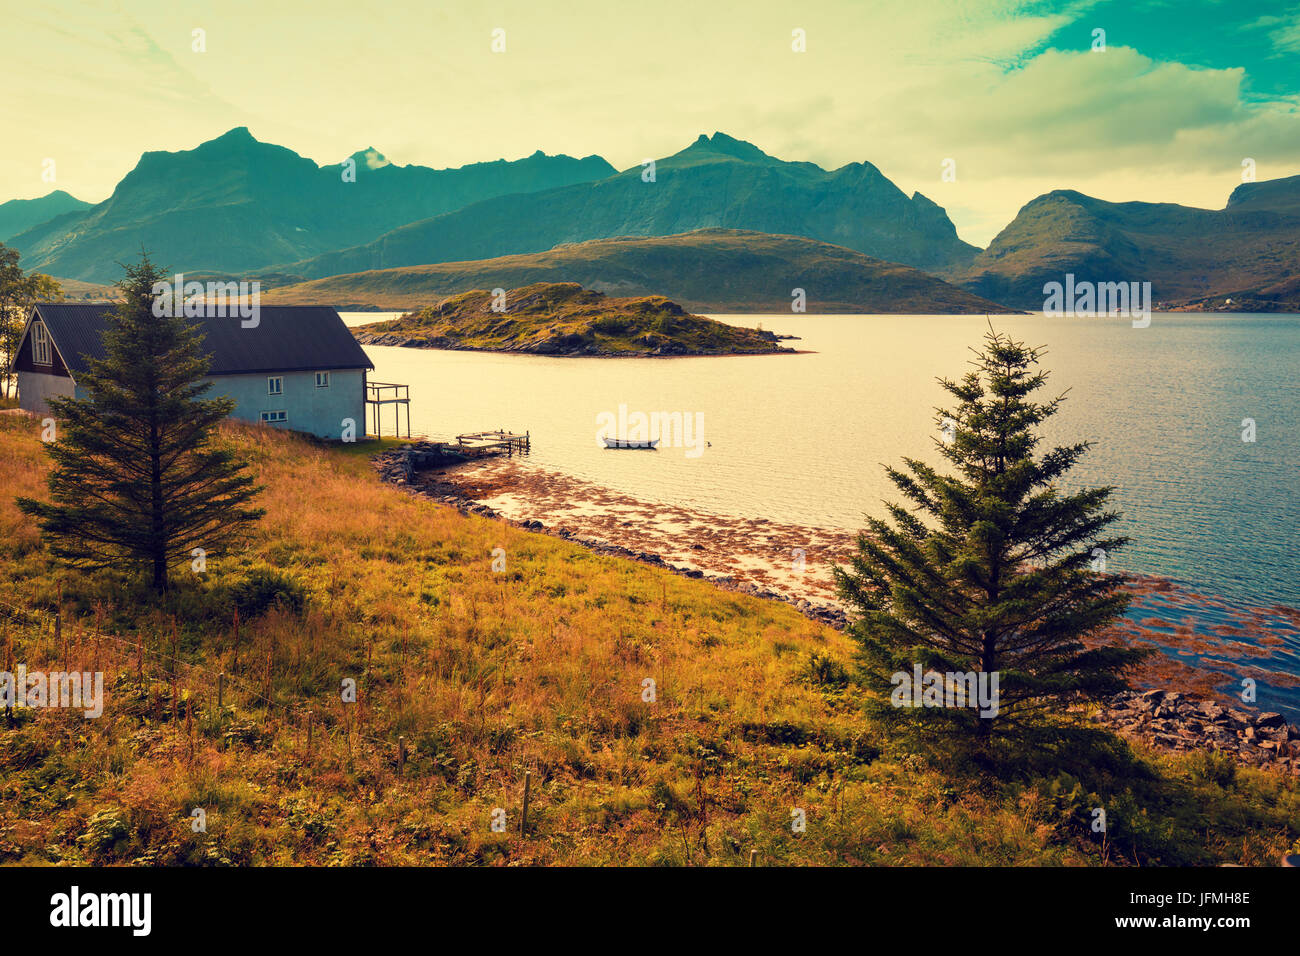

265,229,1006,315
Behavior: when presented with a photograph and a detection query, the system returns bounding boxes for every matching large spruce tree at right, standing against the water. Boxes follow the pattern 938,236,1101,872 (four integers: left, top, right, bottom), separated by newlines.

835,328,1144,741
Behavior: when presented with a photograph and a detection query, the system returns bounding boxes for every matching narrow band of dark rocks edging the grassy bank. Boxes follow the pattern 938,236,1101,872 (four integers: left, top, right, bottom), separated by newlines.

373,442,1300,775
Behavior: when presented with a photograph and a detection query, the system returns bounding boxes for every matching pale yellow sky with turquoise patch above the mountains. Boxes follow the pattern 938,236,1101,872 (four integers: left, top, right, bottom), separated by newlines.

0,0,1300,246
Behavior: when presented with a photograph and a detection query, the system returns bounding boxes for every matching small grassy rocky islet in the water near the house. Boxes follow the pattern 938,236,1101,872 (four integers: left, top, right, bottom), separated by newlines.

352,282,794,358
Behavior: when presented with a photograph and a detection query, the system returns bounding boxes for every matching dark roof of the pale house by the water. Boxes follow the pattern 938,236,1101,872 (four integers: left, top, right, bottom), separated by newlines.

27,302,374,378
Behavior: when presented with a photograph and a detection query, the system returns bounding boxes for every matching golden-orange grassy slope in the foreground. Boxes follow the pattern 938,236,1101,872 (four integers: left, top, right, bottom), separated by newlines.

0,415,1300,865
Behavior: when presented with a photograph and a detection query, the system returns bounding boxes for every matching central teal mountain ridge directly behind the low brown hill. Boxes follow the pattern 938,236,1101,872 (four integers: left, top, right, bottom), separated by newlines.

282,133,978,278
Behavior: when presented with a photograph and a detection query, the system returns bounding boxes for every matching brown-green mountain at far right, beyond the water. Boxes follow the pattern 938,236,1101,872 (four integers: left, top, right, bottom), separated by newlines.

945,176,1300,308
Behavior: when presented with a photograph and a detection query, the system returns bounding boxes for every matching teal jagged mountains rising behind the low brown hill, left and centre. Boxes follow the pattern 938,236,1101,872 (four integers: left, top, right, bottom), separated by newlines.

12,127,979,287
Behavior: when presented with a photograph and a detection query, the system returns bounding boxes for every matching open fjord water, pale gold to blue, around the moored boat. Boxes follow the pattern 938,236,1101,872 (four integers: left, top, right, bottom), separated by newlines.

346,313,1300,606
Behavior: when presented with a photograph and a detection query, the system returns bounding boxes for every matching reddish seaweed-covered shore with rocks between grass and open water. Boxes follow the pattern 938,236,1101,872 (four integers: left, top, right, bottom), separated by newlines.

374,450,1300,775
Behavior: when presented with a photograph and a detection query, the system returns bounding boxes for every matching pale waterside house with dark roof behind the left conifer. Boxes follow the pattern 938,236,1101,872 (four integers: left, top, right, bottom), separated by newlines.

14,303,374,438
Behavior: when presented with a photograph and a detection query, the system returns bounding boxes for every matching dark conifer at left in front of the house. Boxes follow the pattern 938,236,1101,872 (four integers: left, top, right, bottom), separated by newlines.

18,256,264,591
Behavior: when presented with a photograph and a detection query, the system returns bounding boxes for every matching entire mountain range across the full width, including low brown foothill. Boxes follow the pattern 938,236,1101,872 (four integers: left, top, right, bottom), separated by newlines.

0,127,1300,312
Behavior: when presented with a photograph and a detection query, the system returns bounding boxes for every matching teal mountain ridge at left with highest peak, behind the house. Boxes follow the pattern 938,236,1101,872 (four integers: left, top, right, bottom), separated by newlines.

13,127,614,281
